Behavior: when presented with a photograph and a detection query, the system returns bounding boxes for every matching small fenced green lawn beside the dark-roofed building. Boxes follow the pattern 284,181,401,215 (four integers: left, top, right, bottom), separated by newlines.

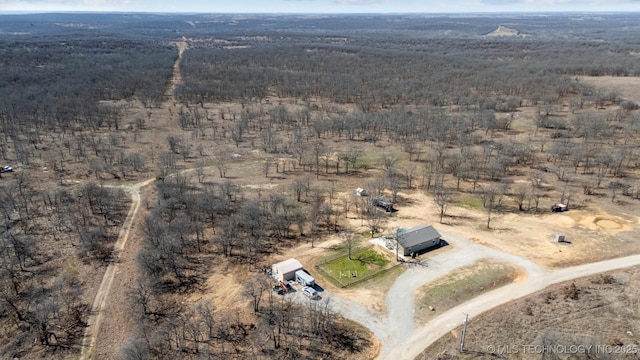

318,249,393,287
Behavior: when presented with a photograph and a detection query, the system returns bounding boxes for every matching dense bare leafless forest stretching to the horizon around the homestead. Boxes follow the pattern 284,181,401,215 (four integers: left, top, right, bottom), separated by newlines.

0,14,640,359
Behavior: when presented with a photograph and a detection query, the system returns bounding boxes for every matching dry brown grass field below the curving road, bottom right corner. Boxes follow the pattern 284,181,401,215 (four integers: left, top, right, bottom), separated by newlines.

417,267,640,360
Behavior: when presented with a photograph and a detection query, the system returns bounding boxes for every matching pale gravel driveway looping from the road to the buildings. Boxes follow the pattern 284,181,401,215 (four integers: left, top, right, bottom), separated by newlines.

294,232,640,360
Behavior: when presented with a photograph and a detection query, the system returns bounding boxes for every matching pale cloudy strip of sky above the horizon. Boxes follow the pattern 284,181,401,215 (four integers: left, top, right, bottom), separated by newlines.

0,0,640,13
